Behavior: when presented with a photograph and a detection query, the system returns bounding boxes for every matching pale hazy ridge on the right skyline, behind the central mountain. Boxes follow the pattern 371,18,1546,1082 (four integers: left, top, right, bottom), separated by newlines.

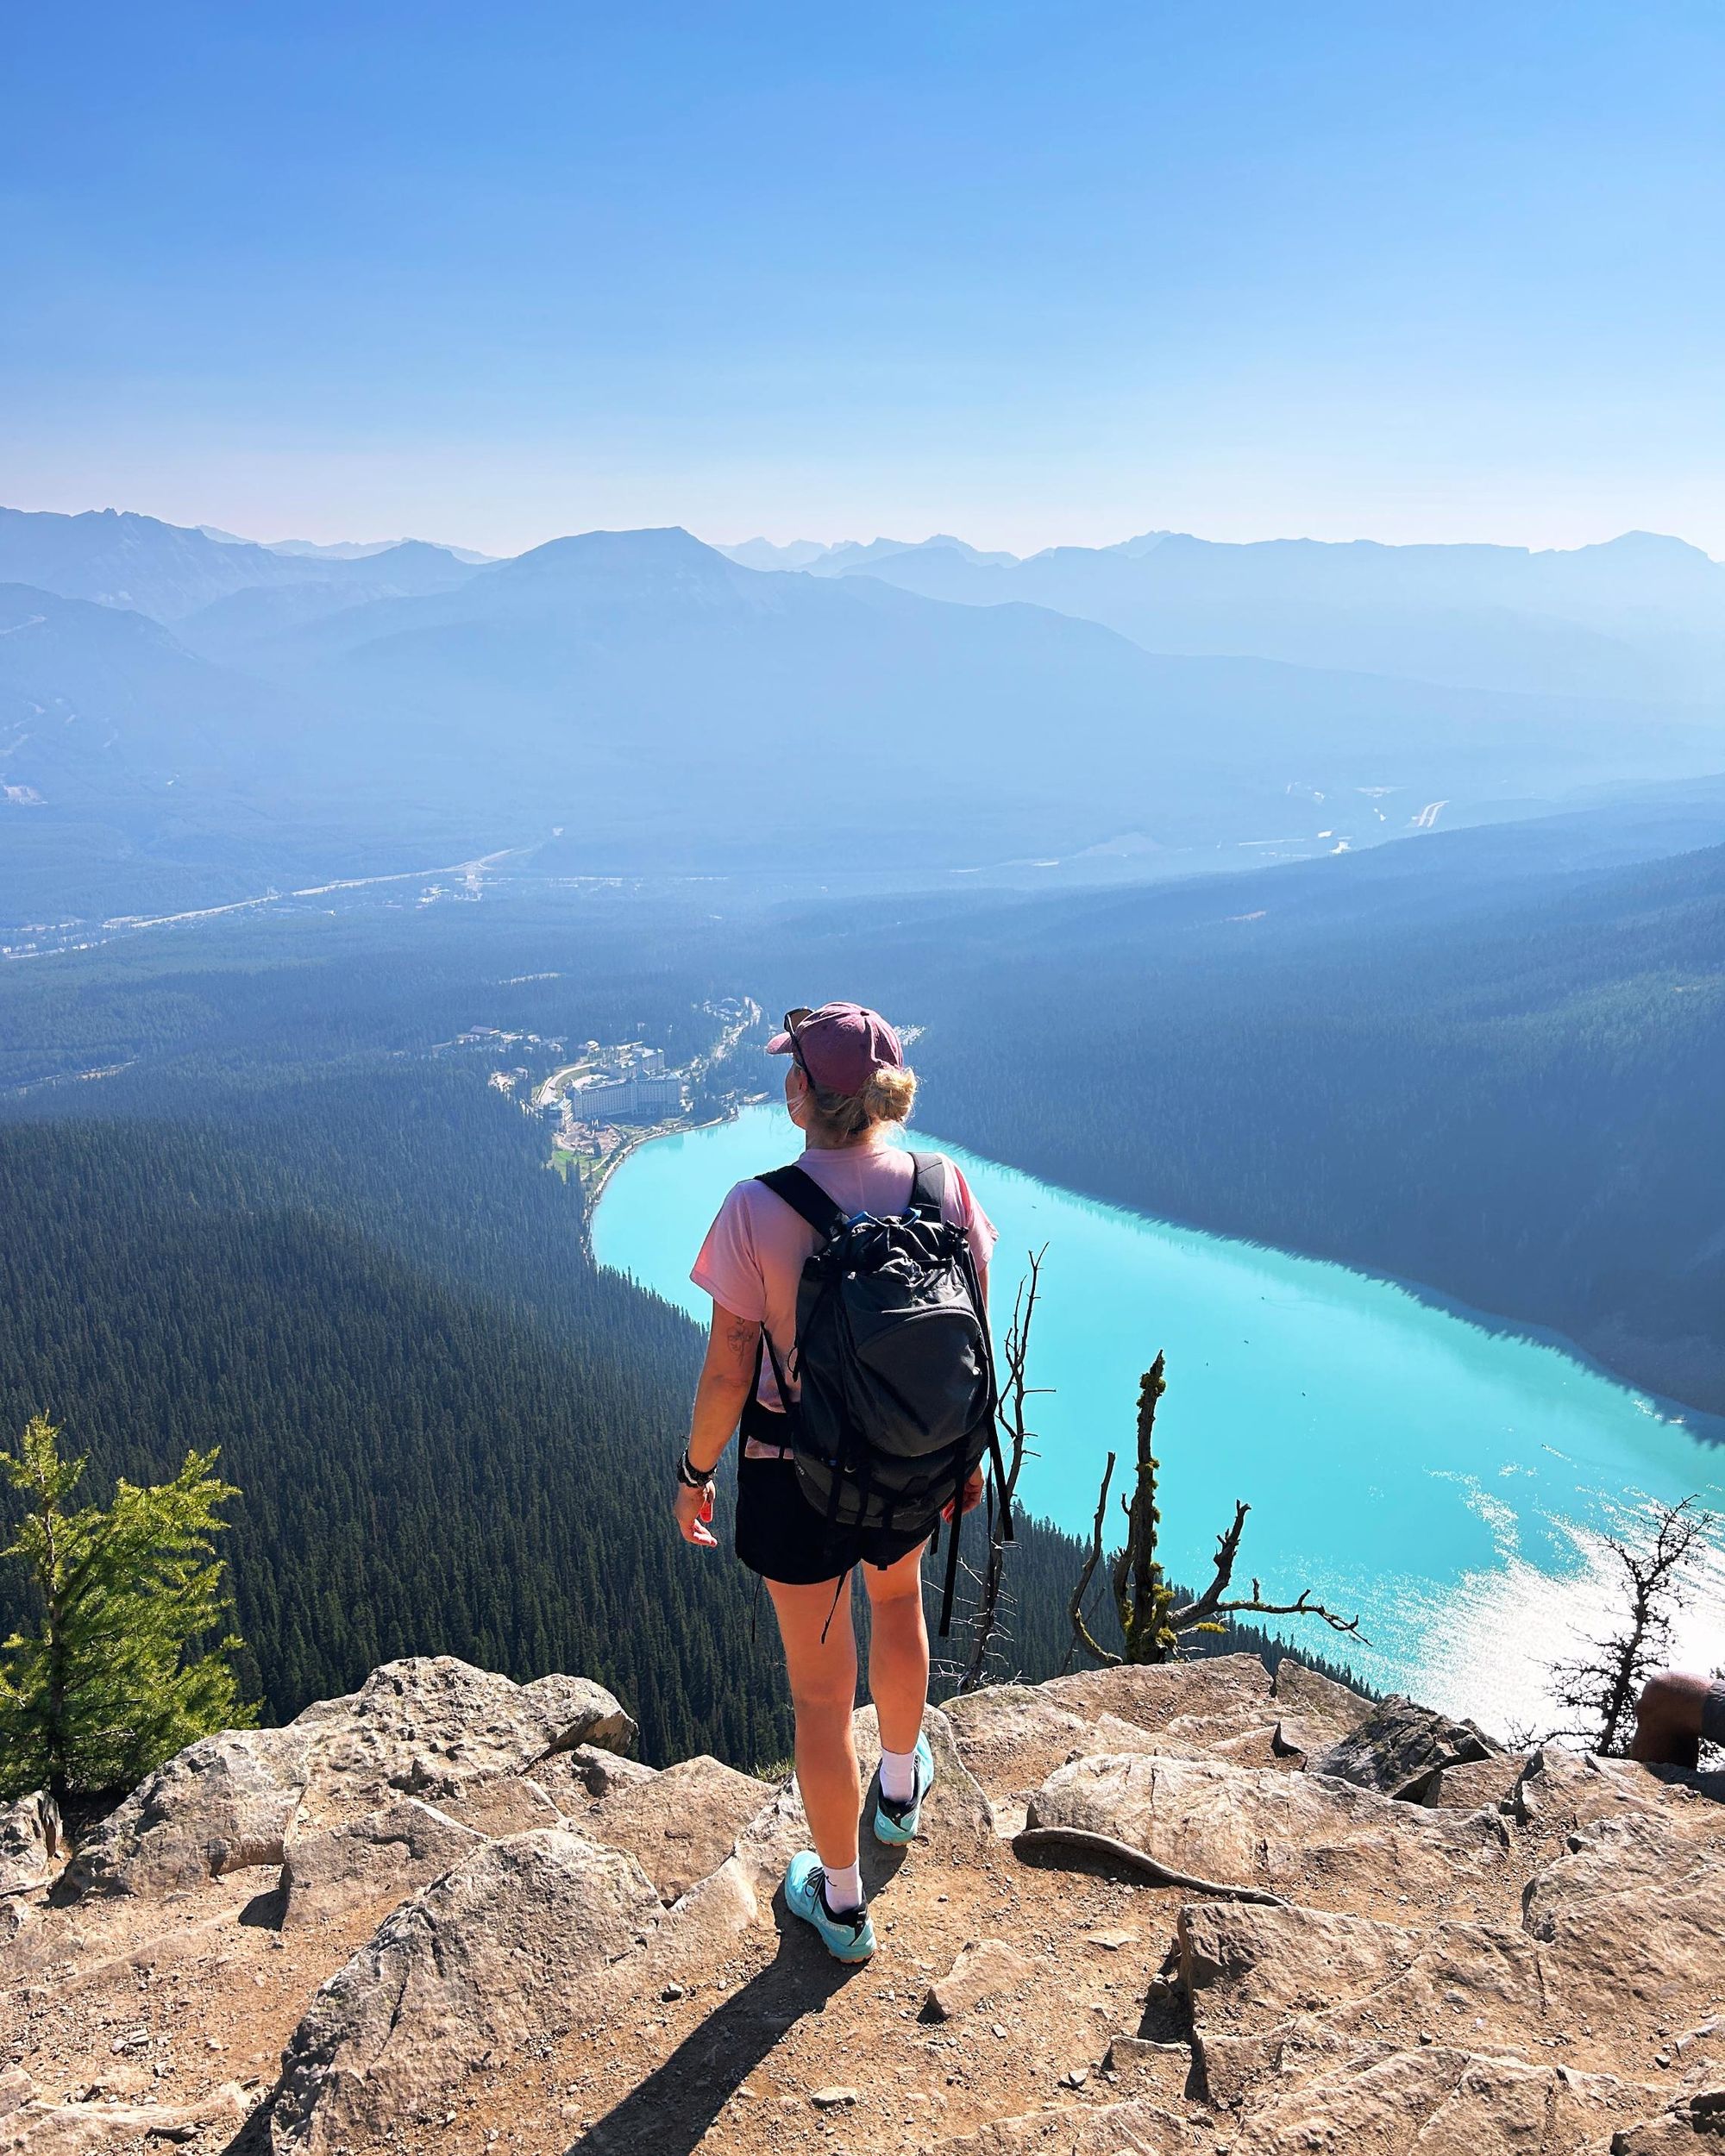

809,533,1725,703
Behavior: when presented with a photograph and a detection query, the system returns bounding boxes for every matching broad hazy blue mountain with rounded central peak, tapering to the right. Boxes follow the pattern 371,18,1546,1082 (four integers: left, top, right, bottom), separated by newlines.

233,530,1725,865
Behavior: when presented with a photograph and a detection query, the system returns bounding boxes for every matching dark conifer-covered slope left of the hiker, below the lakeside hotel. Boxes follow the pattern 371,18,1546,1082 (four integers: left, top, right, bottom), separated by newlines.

0,1081,763,1758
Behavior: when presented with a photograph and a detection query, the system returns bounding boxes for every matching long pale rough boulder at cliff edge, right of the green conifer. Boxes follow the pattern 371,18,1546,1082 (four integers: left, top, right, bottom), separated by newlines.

67,1656,634,1893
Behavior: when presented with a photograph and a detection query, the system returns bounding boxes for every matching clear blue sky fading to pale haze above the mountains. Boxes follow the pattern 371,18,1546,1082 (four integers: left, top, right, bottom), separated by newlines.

0,0,1725,555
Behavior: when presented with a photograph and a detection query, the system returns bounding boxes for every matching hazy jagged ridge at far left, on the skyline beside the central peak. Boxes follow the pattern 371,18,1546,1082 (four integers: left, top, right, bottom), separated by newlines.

0,509,485,621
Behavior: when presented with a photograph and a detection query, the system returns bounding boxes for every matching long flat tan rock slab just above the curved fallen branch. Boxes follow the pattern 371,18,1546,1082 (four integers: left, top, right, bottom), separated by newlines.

1029,1758,1508,1904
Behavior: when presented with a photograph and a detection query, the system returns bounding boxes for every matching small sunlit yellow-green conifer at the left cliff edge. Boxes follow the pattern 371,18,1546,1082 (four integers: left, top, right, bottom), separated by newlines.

0,1417,254,1798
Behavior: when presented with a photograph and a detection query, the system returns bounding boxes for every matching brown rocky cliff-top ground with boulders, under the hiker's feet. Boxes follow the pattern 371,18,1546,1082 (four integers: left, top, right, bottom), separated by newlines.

0,1656,1725,2156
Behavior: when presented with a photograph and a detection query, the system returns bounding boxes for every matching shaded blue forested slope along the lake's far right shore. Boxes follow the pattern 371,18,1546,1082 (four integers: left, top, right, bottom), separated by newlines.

759,826,1725,1410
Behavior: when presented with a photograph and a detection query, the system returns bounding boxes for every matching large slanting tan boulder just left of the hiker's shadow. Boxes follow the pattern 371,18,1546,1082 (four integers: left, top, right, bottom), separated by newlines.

270,1828,660,2156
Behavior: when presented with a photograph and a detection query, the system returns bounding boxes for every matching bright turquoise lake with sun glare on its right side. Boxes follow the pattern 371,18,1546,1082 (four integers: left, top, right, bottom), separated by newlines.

593,1106,1725,1729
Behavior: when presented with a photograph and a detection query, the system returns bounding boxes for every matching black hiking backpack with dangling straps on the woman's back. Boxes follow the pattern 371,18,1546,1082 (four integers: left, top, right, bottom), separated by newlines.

757,1154,1012,1637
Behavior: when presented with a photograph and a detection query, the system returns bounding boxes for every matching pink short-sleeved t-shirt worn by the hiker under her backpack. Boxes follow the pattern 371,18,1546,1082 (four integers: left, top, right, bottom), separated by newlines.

690,1141,996,1440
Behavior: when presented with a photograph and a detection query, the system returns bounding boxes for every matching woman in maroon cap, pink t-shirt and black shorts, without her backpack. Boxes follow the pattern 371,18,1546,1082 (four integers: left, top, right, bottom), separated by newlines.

675,1003,994,1962
